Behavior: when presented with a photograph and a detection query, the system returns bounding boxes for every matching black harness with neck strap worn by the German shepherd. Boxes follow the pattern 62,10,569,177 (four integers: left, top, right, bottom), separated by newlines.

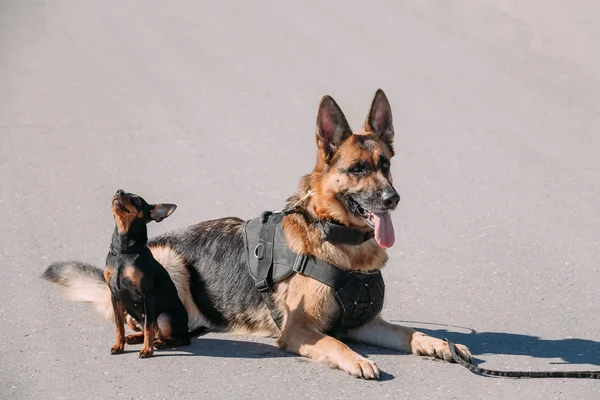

243,211,385,336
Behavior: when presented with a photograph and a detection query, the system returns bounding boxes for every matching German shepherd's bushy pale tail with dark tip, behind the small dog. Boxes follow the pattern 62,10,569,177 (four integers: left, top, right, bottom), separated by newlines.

41,261,114,321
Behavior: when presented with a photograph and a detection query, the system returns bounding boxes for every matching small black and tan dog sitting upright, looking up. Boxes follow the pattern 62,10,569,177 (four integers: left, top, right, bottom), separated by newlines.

104,190,190,358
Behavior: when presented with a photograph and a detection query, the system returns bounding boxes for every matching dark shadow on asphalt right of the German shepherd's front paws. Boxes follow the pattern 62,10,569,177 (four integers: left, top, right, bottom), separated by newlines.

398,321,600,365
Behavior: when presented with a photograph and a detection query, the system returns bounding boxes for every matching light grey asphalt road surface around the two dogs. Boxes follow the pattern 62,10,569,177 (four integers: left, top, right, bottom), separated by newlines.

0,0,600,399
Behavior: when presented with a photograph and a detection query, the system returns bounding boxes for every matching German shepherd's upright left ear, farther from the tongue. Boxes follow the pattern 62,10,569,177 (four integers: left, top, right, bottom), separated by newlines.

317,96,352,161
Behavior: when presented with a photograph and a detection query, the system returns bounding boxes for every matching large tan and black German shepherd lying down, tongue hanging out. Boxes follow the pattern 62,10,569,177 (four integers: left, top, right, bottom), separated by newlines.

44,89,471,379
